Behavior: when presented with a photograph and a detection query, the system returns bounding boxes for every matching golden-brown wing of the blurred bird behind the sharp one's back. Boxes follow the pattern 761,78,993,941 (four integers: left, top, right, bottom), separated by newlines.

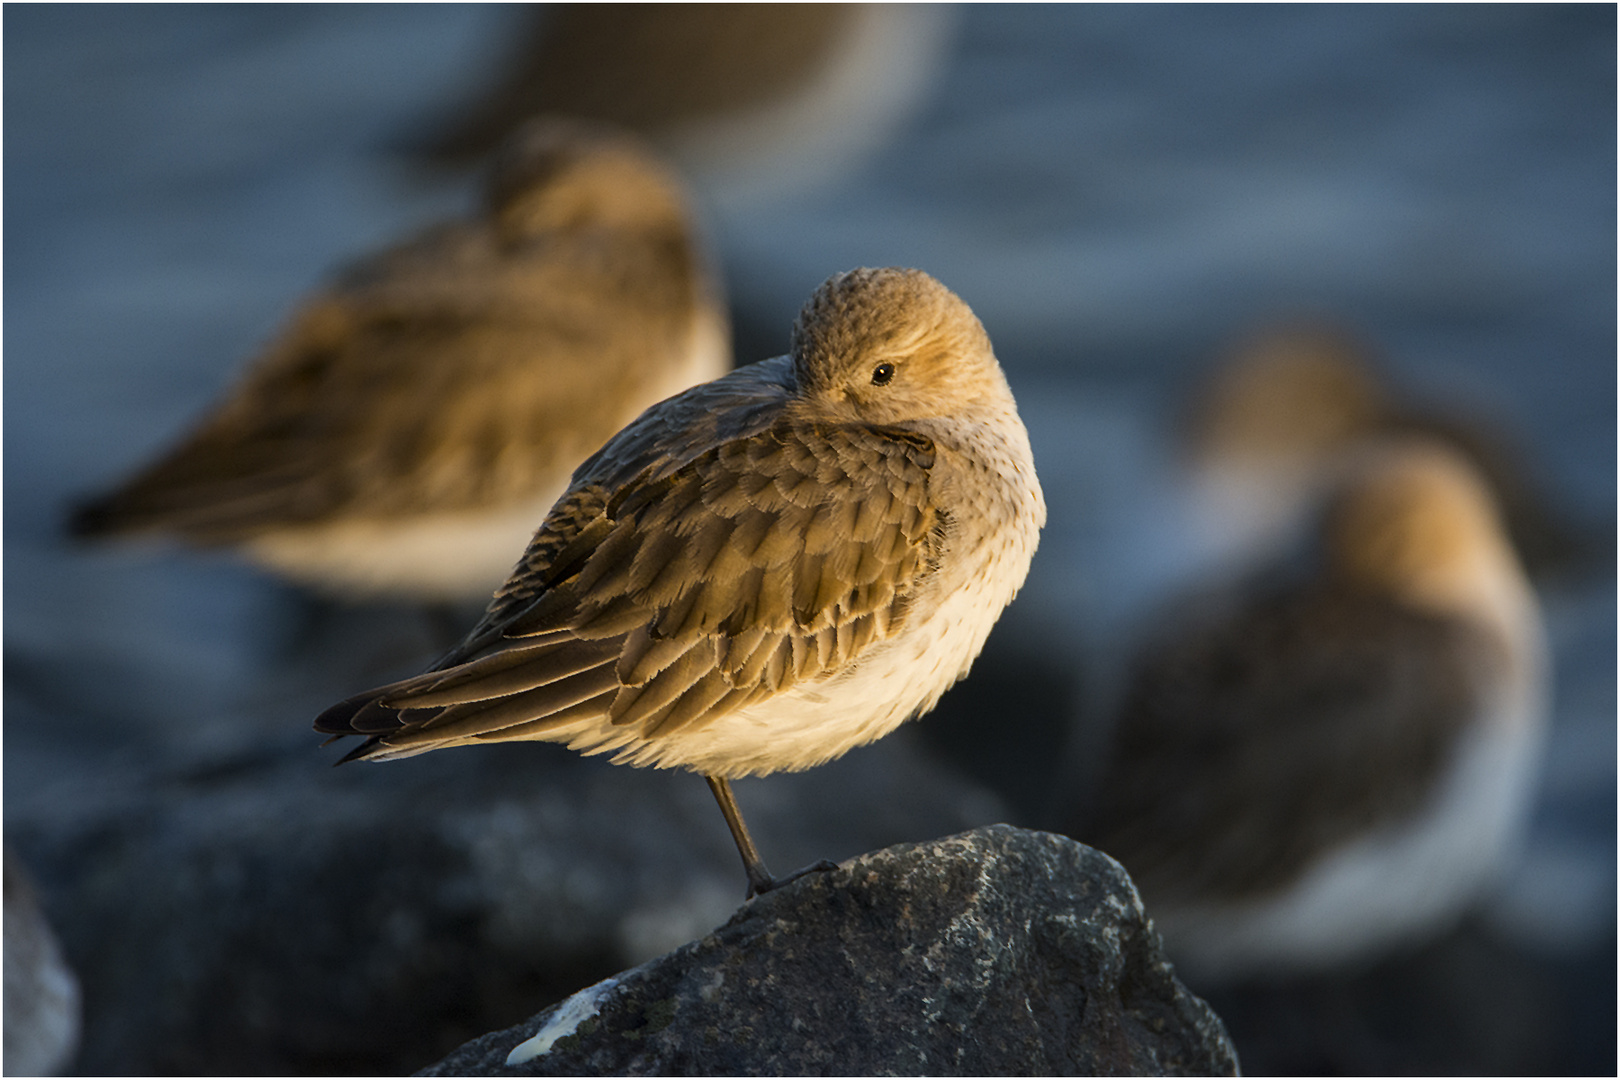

75,228,693,542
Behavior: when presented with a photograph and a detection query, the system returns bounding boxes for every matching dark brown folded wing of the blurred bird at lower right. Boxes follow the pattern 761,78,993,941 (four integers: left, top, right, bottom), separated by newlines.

1085,589,1499,902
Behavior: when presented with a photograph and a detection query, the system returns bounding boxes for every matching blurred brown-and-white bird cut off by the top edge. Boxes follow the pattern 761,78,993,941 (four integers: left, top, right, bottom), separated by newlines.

426,3,951,201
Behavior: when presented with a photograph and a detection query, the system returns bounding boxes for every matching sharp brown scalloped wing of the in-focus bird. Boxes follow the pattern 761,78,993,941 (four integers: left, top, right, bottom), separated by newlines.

316,409,946,756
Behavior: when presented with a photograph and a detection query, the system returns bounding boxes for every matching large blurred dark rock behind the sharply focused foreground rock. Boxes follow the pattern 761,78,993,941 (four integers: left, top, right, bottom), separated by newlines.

6,725,1003,1075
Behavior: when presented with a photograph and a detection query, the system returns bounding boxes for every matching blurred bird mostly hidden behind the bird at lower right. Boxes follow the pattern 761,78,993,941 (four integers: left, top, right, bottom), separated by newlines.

1186,322,1604,573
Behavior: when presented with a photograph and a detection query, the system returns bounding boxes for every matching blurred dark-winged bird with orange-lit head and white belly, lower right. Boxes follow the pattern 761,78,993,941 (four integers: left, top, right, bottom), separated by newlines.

1071,436,1549,983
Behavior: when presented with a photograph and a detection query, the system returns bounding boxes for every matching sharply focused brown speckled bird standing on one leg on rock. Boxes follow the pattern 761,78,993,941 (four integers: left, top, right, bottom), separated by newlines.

314,267,1047,897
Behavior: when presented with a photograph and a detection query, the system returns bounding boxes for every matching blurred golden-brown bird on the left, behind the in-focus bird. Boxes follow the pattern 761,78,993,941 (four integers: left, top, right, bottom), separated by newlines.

68,118,731,604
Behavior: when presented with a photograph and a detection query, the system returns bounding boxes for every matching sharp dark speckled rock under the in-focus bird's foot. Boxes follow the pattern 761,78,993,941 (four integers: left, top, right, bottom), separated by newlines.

420,826,1238,1075
